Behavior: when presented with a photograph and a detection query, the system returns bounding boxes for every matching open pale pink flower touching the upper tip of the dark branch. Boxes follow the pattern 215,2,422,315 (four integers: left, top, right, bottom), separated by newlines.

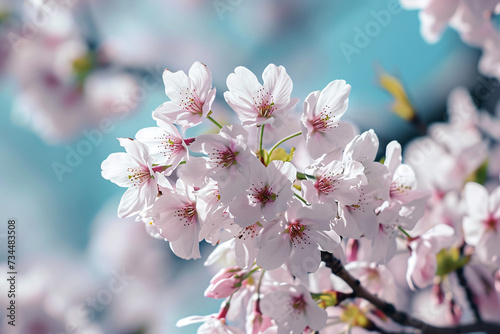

257,200,340,278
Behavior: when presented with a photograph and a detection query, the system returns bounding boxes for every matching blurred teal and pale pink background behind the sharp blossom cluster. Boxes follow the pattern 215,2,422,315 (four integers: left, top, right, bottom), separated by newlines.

0,0,495,334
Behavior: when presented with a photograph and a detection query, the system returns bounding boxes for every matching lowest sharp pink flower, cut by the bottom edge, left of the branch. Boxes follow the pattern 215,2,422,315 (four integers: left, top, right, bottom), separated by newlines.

261,284,327,334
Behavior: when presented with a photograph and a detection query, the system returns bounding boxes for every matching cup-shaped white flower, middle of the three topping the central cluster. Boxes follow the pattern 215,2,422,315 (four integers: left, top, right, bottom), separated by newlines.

224,64,299,126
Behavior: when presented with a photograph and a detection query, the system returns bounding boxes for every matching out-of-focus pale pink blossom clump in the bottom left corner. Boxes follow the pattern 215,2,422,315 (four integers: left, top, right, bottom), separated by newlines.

0,256,105,334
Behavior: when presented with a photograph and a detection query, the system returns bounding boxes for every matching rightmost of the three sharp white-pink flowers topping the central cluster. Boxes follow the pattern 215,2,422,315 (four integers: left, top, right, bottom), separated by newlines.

301,80,354,159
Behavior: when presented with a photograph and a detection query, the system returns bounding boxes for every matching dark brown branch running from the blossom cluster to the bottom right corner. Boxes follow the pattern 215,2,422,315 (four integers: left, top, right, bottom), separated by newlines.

321,252,500,334
